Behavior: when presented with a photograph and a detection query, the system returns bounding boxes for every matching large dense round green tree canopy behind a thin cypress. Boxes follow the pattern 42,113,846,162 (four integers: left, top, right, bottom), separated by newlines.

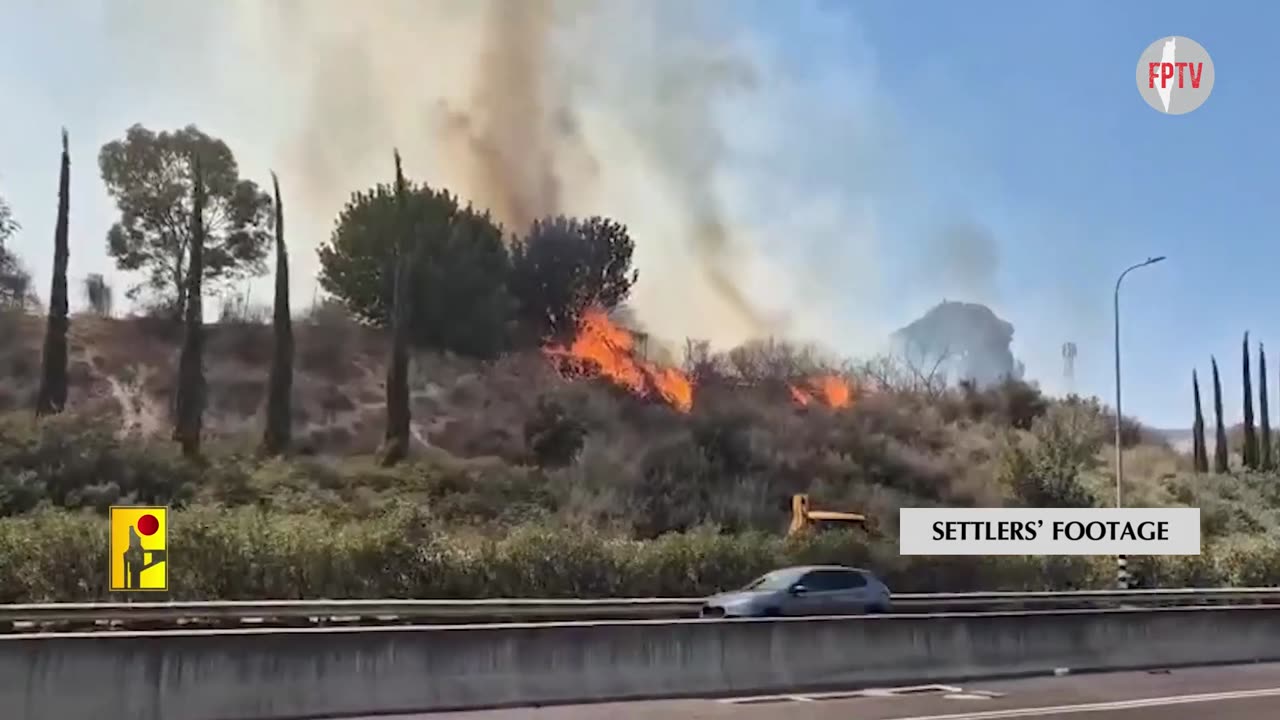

320,183,513,357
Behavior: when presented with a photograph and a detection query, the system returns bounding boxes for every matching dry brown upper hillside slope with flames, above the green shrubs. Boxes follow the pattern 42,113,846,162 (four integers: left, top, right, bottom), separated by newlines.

0,297,1198,520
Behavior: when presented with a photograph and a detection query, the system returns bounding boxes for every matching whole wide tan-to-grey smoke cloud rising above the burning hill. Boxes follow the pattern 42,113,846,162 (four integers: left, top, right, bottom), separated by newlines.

49,0,896,352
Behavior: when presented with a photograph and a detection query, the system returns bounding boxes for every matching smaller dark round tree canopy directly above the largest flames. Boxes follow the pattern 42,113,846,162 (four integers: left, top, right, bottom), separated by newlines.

511,215,639,337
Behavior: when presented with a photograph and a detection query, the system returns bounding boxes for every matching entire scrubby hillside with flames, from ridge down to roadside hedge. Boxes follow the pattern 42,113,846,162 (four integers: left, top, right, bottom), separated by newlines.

0,297,1280,602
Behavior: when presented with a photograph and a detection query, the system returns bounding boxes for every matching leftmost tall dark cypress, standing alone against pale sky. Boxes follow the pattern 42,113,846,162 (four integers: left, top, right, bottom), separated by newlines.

36,128,72,415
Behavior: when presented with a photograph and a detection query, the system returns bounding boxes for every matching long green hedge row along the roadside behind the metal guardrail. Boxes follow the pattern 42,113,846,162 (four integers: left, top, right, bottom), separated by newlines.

0,509,1280,602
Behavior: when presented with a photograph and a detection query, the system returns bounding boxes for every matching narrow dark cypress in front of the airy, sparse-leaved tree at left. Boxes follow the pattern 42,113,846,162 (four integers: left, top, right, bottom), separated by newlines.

173,155,205,457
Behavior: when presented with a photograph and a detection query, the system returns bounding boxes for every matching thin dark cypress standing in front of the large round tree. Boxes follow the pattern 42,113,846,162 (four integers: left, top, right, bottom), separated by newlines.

383,150,412,466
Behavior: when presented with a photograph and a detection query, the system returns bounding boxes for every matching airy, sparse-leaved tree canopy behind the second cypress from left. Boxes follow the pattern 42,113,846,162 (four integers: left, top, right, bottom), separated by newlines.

99,124,271,318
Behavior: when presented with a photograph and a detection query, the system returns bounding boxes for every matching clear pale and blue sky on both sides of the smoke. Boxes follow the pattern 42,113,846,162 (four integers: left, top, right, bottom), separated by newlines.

0,0,1280,427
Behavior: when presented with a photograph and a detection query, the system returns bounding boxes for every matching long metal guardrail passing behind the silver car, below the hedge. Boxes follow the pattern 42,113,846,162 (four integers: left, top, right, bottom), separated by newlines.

0,588,1280,629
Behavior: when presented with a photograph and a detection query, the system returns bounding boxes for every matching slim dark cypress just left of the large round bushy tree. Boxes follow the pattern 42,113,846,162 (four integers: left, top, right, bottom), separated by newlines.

262,173,293,455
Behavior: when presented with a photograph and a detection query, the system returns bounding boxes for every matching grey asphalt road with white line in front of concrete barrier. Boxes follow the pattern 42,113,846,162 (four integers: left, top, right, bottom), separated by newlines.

350,664,1280,720
